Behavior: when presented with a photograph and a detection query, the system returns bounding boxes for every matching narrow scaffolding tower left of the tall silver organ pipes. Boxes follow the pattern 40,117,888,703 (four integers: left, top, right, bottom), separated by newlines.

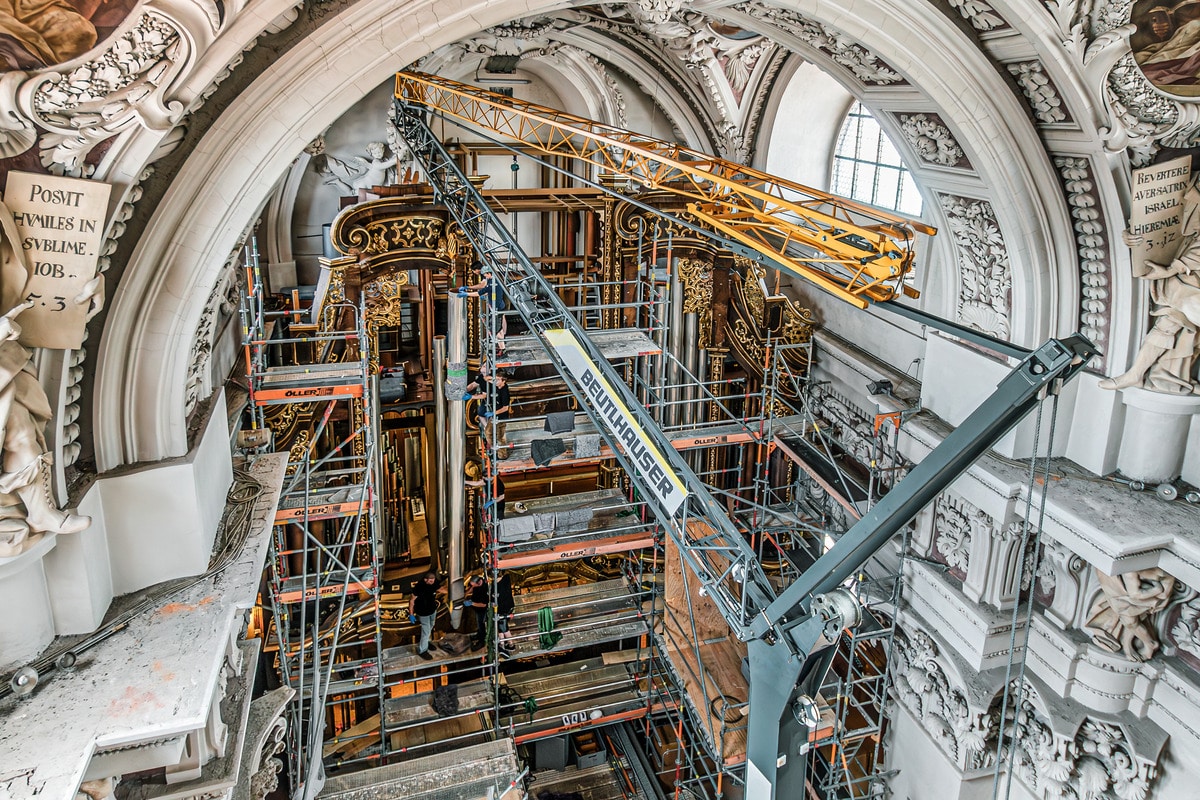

241,241,386,782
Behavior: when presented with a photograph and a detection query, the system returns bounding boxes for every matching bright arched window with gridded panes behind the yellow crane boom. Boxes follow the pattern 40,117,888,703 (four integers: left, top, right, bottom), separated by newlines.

829,102,922,217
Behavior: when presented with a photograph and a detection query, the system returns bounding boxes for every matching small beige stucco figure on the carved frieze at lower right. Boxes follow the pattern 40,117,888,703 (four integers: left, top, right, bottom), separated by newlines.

1086,567,1175,661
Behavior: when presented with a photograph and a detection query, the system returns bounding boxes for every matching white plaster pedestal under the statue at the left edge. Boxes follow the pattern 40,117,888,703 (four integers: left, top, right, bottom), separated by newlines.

0,536,54,670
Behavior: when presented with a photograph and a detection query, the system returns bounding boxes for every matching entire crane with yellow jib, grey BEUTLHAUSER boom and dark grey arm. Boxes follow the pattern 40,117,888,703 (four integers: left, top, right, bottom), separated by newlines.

396,73,1096,800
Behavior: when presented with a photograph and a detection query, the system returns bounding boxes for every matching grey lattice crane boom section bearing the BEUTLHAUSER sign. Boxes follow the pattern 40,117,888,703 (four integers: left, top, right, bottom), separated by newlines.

397,95,774,634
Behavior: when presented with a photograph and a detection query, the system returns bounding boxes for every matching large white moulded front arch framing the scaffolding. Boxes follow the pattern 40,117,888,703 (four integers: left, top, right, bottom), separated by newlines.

96,0,1074,470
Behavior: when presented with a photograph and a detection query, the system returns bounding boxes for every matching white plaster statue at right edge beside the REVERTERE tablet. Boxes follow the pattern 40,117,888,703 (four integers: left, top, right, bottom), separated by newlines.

1100,179,1200,395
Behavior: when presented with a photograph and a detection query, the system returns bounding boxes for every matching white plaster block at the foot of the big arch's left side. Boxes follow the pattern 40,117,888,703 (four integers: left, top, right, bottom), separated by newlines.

100,393,233,595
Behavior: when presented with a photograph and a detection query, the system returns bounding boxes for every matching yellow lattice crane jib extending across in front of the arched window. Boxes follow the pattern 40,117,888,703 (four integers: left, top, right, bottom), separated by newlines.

396,72,935,308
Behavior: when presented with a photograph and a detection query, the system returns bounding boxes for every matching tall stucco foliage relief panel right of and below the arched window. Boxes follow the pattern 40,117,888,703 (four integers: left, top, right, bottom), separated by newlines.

938,194,1013,338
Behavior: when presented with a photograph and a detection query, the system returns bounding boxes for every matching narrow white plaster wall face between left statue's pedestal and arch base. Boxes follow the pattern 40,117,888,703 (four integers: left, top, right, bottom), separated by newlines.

46,483,113,636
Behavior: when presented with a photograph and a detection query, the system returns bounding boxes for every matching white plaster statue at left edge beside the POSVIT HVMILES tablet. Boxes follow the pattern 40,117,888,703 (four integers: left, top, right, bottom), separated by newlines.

0,196,93,557
